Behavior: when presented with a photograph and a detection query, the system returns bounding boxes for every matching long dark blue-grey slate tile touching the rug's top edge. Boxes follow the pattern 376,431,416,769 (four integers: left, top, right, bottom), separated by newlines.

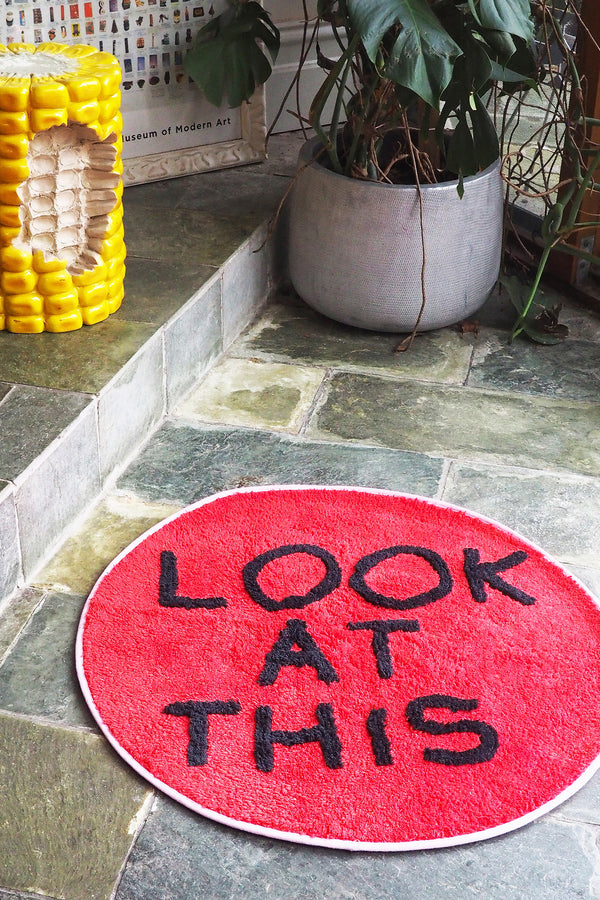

117,423,442,504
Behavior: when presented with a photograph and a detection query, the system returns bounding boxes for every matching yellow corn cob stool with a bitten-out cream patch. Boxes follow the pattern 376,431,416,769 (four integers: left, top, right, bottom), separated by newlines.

0,44,125,334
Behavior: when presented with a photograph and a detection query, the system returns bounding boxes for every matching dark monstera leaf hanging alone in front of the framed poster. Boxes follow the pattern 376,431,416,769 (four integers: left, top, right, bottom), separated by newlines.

184,0,279,108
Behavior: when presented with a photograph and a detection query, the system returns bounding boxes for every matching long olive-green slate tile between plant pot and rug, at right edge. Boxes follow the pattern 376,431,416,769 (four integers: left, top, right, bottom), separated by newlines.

308,373,600,475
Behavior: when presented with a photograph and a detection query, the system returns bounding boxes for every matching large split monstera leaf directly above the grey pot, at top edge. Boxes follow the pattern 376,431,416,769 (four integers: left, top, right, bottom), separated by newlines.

347,0,462,106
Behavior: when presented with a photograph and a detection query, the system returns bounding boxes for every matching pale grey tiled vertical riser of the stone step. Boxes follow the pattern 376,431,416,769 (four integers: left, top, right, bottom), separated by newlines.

0,222,280,616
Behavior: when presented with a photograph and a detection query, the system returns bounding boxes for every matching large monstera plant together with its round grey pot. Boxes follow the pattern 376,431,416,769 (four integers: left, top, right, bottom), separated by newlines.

186,0,600,342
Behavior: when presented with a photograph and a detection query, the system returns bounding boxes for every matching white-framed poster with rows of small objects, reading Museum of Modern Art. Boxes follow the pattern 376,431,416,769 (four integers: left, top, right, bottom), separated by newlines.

0,0,266,184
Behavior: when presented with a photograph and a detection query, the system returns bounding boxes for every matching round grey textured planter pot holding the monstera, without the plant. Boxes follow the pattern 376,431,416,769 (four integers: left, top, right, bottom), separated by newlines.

288,141,503,332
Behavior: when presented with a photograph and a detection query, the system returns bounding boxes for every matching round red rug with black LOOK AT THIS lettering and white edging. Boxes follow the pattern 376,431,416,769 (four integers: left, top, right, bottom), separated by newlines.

77,486,600,850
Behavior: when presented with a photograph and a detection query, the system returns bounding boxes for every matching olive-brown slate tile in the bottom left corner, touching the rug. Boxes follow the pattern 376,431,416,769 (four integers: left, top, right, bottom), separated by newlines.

0,714,149,900
